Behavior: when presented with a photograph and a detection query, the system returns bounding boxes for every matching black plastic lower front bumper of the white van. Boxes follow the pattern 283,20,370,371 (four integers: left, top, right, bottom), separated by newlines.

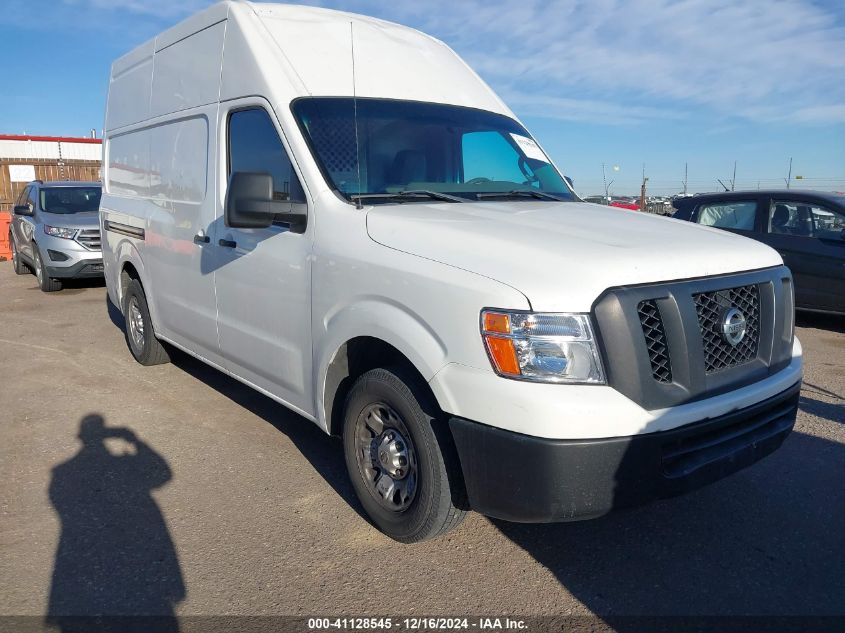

450,382,801,523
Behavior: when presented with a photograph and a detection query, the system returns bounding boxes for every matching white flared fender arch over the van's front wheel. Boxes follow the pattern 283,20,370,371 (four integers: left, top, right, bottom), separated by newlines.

314,297,447,432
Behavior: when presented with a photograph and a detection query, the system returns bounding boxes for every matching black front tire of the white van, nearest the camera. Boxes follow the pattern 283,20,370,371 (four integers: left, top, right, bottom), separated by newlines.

343,367,466,543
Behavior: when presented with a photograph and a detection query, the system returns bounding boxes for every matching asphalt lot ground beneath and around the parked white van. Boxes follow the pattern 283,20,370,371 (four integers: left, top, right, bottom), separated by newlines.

0,262,845,616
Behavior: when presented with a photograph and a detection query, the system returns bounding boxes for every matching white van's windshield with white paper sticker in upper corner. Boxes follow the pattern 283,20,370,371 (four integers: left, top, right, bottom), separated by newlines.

292,97,576,204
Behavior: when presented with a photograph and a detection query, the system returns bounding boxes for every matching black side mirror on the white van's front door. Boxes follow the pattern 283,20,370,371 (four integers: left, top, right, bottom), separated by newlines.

224,171,307,233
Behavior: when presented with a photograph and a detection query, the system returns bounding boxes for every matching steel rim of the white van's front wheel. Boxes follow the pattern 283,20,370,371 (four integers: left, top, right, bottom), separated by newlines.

355,402,419,513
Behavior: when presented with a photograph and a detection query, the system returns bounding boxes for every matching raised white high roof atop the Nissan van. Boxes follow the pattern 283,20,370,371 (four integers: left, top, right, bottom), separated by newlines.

106,0,513,130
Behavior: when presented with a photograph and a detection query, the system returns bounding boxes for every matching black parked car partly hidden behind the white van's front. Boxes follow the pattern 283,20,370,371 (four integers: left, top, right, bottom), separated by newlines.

673,189,845,314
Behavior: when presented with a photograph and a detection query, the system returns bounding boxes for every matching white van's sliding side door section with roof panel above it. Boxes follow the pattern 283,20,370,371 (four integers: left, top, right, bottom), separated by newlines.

136,22,226,361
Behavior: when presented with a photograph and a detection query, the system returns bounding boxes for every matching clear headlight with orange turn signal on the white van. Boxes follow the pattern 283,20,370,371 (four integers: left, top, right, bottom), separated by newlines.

481,310,605,384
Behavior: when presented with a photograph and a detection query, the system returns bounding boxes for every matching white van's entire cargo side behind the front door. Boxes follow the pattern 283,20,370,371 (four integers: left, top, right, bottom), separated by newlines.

102,18,226,362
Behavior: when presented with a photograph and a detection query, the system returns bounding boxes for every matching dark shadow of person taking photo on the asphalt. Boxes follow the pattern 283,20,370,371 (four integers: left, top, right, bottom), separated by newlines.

46,415,186,633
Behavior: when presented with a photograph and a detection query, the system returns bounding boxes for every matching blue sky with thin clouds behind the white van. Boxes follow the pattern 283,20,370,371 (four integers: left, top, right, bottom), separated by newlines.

0,0,845,195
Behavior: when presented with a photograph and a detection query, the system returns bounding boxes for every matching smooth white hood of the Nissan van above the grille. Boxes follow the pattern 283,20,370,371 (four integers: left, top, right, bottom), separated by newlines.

367,201,783,312
